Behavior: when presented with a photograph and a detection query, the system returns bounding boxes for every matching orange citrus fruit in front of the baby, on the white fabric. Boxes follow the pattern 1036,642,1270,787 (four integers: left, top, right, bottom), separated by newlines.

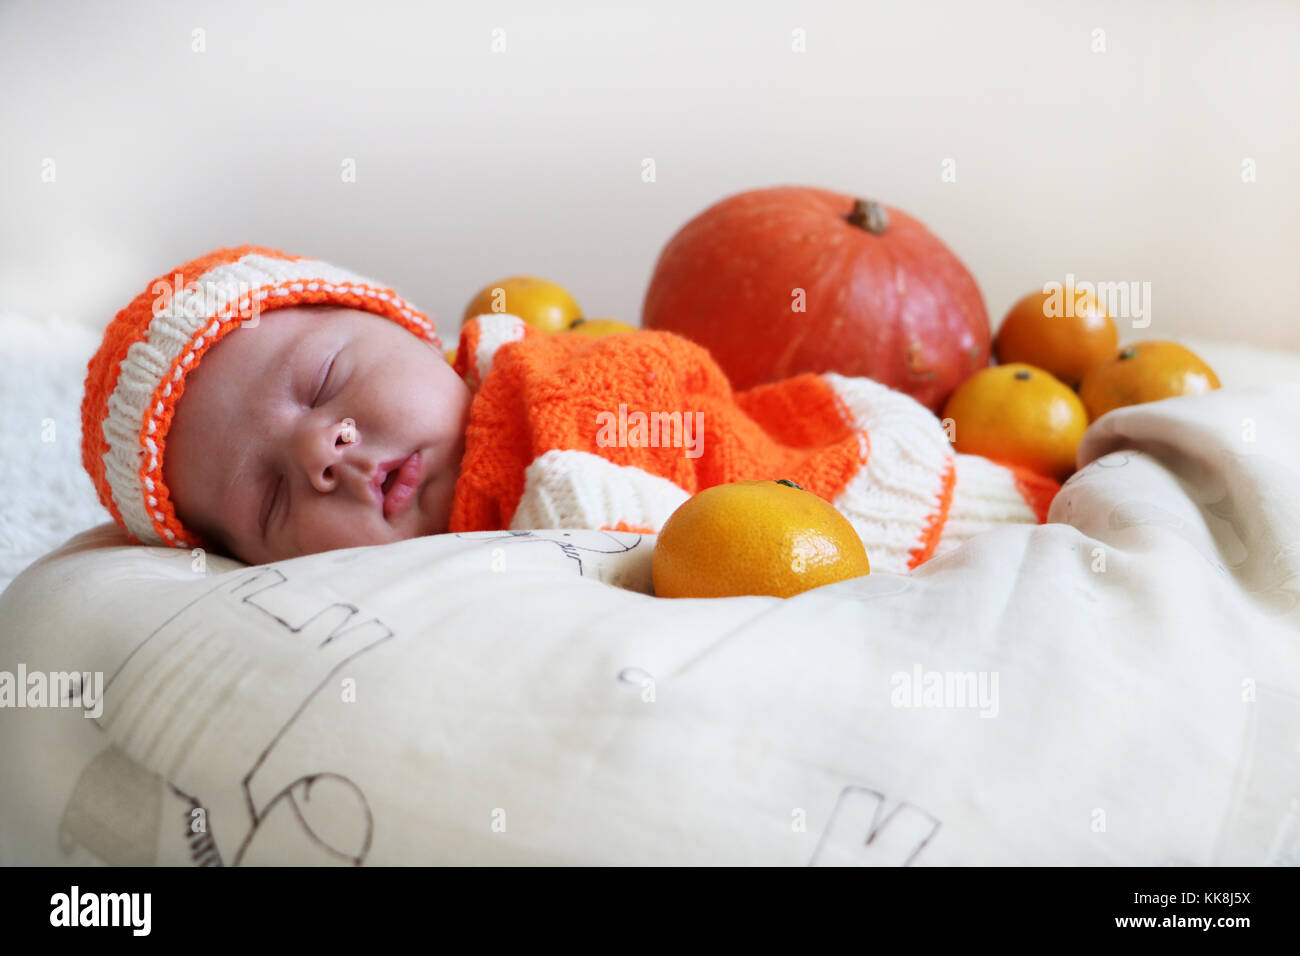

651,479,871,597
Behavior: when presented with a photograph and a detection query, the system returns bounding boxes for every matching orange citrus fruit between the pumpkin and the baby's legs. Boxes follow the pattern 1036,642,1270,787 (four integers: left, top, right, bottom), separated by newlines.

944,362,1088,481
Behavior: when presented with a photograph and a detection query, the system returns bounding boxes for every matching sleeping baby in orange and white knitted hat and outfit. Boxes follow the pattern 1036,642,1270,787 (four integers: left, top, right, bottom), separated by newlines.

82,246,1060,572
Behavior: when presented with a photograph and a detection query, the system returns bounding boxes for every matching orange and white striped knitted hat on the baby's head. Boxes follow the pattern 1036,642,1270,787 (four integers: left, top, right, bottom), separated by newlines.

82,246,442,548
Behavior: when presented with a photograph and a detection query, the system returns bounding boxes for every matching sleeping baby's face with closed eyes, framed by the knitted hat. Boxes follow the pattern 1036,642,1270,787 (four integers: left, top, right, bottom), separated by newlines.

163,306,471,564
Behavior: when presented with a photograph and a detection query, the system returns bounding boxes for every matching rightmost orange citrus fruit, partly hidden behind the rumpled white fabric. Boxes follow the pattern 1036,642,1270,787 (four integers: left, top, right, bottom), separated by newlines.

1079,342,1219,421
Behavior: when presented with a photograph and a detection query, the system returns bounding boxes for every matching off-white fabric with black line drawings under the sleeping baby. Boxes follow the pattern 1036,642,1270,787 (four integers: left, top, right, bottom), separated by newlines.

0,374,1300,865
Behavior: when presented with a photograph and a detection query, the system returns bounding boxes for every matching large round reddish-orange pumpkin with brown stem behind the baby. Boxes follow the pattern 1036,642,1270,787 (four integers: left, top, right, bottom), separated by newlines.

641,186,992,412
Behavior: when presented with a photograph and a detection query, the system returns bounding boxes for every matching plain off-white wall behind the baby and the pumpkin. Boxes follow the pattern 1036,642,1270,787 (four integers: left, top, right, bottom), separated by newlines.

0,0,1300,350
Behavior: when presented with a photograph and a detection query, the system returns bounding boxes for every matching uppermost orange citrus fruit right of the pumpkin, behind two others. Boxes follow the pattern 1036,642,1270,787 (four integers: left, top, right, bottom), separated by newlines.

993,293,1119,388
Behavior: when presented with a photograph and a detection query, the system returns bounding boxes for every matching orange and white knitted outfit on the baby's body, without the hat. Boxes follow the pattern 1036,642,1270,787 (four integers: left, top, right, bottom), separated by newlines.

450,315,1060,572
